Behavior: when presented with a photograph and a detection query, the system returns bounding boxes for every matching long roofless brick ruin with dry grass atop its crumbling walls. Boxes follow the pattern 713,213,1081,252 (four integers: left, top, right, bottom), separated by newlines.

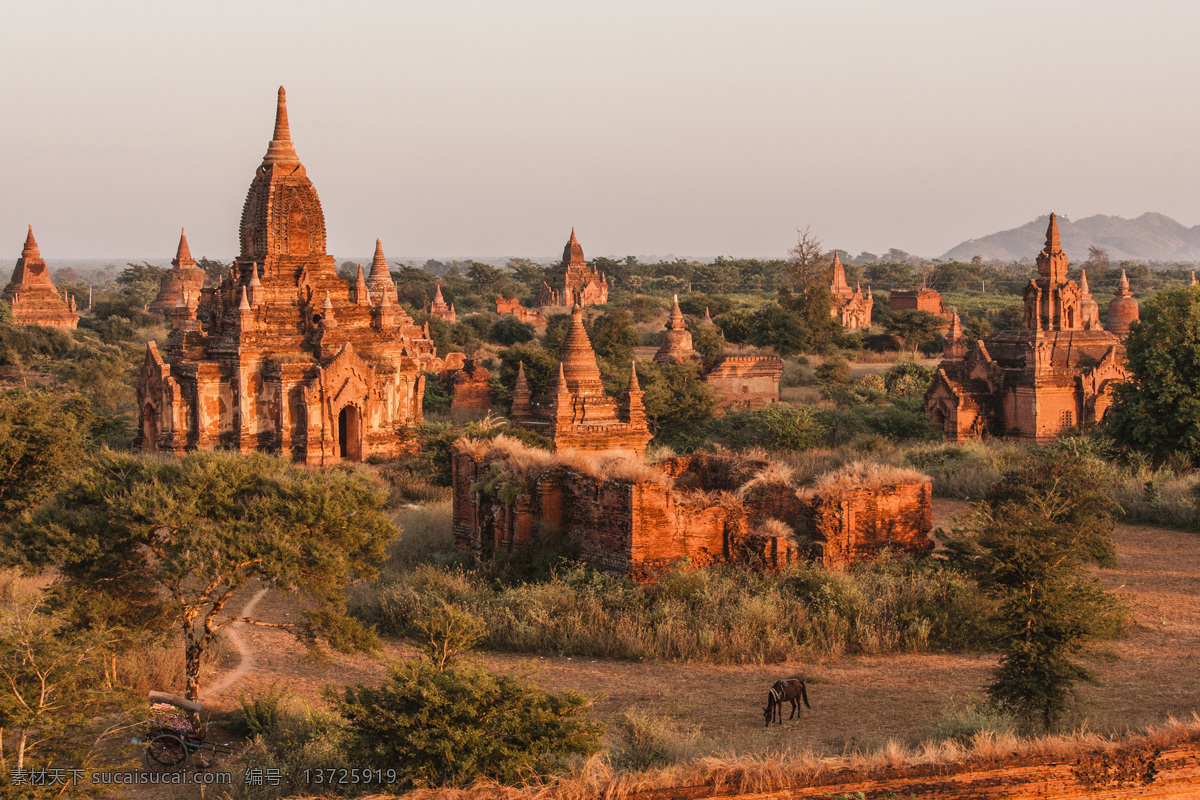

452,437,931,581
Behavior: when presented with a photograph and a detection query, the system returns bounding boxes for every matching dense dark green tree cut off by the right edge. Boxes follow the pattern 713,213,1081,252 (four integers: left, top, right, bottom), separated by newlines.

1105,287,1200,464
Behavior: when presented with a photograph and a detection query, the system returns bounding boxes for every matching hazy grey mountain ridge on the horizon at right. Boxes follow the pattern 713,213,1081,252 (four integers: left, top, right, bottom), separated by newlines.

942,212,1200,261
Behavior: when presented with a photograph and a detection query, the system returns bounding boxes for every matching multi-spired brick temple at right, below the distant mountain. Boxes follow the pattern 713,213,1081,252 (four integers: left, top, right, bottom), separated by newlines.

925,213,1138,441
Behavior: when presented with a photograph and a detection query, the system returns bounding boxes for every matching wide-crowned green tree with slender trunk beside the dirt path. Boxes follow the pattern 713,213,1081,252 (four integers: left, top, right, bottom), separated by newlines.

6,451,396,699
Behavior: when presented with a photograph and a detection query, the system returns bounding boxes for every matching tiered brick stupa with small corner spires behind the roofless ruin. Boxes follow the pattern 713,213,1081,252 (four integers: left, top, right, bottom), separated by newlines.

511,306,652,456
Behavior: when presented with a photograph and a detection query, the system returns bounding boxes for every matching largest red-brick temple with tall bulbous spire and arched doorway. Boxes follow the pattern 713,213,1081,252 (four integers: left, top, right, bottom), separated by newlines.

138,88,446,464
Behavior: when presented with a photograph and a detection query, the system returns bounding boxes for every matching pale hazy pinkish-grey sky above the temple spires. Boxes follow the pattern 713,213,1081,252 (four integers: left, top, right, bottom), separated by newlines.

0,0,1200,265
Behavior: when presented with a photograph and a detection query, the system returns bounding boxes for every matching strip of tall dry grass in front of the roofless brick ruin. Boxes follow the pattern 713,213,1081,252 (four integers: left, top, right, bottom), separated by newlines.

353,557,990,663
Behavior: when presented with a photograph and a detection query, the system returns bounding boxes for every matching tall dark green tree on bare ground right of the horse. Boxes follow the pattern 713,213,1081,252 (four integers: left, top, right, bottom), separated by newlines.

947,450,1121,728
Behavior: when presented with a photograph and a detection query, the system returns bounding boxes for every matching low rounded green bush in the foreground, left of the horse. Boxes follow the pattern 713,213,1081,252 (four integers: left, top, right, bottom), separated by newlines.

326,661,601,789
